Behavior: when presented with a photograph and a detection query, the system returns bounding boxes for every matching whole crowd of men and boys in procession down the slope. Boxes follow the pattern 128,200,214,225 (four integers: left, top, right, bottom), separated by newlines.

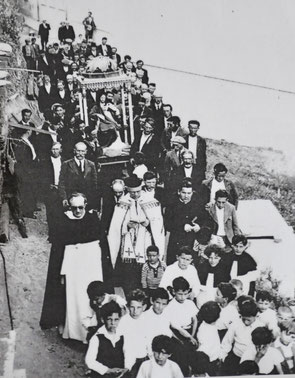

10,12,295,378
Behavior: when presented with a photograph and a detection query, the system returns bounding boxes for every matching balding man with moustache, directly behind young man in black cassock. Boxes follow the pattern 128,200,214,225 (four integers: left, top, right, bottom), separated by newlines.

170,150,205,194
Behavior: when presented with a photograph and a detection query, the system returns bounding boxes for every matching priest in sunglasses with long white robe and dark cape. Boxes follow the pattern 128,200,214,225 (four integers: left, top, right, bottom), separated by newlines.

60,193,103,343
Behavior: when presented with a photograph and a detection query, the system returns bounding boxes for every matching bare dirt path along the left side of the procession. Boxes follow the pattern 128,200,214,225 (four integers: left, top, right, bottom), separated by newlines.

0,208,85,378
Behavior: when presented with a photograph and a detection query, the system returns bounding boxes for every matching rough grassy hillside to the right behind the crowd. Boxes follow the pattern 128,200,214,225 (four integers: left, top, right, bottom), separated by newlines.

207,140,295,230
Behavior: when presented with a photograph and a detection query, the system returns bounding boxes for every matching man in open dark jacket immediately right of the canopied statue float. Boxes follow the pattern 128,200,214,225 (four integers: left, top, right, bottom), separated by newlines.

130,118,161,171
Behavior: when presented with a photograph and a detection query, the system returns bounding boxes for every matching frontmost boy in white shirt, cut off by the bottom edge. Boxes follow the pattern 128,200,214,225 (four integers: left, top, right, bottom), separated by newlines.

137,335,183,378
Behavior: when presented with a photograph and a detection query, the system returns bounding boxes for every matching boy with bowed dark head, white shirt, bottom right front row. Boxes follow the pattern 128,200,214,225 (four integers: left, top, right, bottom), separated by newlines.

241,327,284,375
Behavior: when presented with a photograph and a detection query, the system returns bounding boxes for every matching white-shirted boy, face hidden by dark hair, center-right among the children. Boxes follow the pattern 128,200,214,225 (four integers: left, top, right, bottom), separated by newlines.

197,301,221,375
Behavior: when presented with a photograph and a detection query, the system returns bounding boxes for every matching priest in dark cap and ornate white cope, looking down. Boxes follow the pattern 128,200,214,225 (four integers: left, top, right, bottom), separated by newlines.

108,176,165,290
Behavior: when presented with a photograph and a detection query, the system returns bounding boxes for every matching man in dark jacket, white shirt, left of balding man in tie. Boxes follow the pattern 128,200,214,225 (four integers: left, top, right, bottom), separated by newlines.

41,142,63,241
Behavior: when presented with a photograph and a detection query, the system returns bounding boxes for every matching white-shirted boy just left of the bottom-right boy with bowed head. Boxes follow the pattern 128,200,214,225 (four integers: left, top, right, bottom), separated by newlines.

221,296,263,375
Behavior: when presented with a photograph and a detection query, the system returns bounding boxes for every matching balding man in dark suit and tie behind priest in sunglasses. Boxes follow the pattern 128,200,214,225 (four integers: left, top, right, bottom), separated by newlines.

59,142,99,209
